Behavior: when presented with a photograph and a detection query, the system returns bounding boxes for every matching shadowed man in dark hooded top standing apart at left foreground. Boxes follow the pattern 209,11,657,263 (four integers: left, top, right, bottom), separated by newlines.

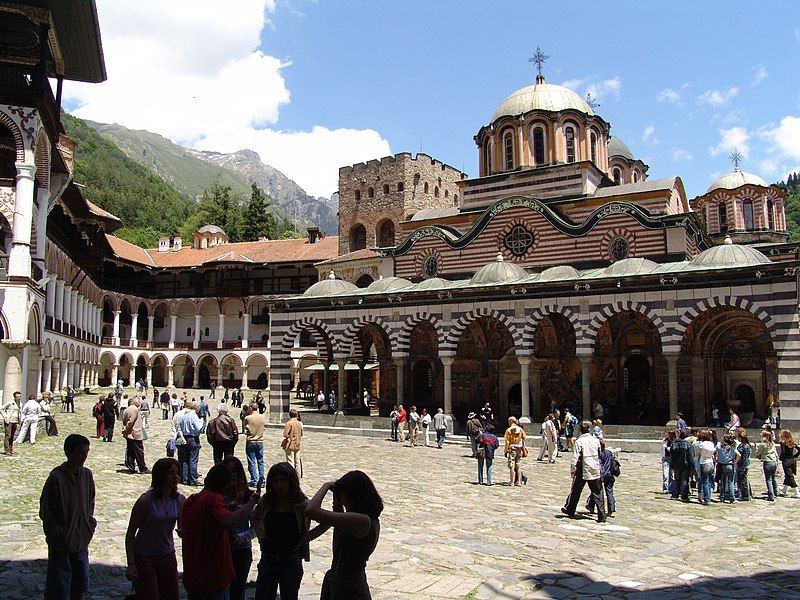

39,433,97,600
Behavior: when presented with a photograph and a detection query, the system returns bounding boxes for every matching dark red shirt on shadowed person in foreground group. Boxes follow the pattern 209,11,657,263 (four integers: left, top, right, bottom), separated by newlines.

181,490,235,593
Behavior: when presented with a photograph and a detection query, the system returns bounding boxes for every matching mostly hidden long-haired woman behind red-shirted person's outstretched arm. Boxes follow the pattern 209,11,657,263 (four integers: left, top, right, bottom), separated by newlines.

222,455,255,600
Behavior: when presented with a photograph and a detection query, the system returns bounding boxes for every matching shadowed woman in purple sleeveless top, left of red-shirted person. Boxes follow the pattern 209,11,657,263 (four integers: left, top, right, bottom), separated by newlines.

125,458,186,600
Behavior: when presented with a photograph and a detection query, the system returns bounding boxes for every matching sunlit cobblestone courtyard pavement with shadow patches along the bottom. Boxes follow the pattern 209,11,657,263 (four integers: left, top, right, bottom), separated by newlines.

0,398,800,599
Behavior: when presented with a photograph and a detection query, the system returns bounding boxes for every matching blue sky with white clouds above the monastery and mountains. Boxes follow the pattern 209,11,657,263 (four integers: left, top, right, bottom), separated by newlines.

64,0,800,198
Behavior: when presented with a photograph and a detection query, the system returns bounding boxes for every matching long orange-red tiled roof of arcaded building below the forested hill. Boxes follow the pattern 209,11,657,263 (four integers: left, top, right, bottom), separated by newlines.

106,235,339,268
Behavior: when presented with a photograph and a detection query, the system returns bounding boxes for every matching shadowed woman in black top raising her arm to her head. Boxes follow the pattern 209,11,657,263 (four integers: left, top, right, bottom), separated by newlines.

306,471,383,600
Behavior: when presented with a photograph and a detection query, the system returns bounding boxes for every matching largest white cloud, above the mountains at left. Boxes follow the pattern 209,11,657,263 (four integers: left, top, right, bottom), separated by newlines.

64,0,389,196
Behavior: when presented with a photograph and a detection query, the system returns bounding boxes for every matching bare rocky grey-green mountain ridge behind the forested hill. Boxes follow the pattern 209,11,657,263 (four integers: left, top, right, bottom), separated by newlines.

87,121,338,235
